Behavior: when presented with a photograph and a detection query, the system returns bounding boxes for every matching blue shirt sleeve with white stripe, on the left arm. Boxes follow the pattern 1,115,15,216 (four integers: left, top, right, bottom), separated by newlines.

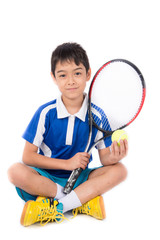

22,107,46,147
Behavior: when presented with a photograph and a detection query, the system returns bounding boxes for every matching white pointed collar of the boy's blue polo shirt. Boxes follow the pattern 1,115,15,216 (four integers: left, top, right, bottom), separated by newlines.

57,94,88,122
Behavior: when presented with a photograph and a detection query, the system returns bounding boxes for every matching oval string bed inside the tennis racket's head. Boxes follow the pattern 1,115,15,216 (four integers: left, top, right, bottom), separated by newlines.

90,61,144,131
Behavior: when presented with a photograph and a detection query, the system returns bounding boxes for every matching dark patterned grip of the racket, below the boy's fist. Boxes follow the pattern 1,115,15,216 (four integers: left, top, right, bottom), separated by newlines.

63,168,83,194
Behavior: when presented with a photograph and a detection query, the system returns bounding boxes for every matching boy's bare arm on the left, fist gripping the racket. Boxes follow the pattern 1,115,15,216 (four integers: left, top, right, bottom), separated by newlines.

22,141,90,170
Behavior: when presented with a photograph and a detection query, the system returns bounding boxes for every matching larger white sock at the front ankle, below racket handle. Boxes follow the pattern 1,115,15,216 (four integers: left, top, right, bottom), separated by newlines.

58,190,82,213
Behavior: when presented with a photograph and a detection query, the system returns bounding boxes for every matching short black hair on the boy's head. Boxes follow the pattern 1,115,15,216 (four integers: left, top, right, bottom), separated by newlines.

51,42,90,76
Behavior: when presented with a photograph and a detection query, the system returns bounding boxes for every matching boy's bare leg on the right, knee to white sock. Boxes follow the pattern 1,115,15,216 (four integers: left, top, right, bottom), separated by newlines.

74,163,127,204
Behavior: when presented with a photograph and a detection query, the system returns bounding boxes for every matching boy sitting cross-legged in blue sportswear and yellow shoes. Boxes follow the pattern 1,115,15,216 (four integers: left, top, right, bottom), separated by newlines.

8,43,128,226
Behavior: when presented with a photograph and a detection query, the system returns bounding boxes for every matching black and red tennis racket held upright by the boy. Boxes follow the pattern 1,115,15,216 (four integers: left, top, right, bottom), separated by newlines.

64,59,146,194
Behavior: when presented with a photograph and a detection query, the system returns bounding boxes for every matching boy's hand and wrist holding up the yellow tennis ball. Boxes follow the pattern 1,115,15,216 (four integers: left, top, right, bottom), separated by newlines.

99,140,128,166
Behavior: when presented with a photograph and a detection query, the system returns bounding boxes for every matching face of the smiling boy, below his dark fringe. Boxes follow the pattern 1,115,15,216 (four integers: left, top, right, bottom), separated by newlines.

51,61,91,100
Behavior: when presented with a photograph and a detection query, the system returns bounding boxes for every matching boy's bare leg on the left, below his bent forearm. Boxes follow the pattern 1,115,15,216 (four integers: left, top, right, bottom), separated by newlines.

8,163,57,197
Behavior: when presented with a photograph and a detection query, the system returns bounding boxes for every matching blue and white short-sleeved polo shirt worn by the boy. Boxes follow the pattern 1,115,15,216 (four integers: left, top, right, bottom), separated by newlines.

23,95,111,178
